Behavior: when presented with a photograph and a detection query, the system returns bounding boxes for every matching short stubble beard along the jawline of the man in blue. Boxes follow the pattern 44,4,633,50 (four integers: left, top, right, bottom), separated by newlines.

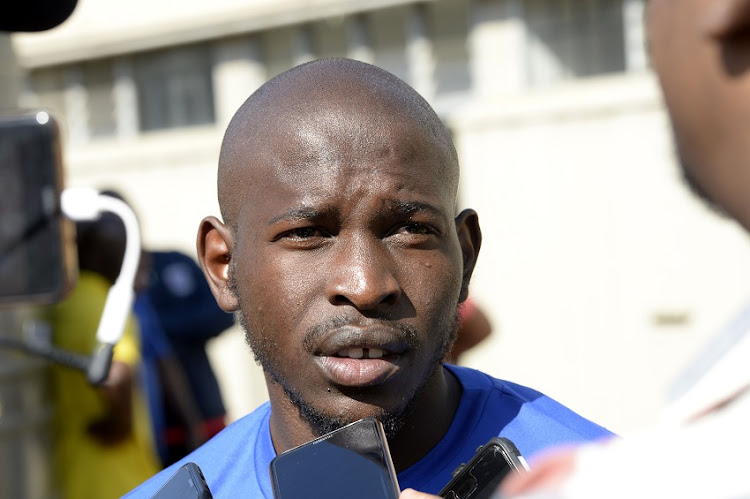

229,262,459,438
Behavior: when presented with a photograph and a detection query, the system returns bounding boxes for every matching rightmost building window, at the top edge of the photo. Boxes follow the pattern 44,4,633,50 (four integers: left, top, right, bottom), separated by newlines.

523,0,626,86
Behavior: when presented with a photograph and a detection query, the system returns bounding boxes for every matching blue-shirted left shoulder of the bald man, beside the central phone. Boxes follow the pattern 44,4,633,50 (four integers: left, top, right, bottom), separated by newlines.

125,403,274,499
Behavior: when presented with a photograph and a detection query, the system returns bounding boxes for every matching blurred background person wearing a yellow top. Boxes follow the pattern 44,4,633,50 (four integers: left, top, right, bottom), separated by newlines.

47,216,159,499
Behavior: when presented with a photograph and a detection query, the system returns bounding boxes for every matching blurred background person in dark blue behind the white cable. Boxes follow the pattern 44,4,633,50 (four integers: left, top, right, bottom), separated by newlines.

102,189,219,466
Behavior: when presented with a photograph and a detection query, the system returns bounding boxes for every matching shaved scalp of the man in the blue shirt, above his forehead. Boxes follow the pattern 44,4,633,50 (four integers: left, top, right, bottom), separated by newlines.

218,59,459,229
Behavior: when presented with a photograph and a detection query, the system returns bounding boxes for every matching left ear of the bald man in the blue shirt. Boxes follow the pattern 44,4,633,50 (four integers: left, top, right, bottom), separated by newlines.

196,217,239,312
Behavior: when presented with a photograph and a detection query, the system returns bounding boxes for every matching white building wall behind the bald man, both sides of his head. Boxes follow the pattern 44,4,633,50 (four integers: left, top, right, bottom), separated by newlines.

10,0,750,438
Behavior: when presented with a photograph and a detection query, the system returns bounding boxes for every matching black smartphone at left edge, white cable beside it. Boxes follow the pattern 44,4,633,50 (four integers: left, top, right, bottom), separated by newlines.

0,111,77,305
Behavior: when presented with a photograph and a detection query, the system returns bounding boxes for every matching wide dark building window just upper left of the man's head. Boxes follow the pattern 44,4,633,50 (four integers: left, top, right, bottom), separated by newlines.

134,45,214,131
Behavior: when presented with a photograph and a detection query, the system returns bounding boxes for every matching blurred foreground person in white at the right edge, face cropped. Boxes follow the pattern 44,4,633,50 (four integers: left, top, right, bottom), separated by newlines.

402,0,750,499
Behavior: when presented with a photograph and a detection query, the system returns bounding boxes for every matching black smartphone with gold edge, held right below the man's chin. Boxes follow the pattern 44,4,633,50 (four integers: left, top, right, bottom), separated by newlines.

270,418,399,499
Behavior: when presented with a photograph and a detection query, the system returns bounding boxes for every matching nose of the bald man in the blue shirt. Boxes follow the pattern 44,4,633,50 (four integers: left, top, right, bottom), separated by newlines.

326,236,401,310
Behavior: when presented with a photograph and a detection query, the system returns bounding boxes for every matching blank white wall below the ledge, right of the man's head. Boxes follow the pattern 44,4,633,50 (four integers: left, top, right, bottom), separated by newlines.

454,73,750,432
